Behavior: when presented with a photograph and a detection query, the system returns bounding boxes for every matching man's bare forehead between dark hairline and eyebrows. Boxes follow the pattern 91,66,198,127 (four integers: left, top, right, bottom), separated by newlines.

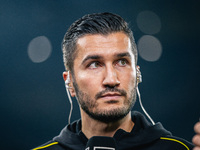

76,32,133,59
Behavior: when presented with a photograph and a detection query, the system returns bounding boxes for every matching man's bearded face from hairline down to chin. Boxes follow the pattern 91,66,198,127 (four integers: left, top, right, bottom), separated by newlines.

72,32,136,122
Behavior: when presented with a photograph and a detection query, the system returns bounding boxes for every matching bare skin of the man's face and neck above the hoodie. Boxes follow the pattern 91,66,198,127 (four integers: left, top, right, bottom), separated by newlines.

63,32,136,138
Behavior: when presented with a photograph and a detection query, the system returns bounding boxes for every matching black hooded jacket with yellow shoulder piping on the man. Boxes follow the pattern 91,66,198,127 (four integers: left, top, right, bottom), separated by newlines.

33,111,193,150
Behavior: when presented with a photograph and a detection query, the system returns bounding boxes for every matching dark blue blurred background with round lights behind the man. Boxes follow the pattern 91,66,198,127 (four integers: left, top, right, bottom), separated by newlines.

0,0,200,150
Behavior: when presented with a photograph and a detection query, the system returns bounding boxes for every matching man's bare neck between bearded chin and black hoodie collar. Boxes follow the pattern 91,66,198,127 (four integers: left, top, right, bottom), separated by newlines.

81,110,134,139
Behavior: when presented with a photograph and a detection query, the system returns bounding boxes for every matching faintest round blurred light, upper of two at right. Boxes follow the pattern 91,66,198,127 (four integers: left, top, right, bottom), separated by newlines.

136,11,161,34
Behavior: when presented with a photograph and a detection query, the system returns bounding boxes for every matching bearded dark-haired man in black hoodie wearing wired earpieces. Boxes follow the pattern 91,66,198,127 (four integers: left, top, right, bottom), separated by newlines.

34,13,200,150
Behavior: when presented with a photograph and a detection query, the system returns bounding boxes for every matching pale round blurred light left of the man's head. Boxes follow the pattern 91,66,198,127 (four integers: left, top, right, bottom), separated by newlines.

28,36,52,63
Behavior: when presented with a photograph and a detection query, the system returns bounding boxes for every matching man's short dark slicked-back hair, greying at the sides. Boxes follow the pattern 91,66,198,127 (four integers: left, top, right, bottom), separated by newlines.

62,12,137,73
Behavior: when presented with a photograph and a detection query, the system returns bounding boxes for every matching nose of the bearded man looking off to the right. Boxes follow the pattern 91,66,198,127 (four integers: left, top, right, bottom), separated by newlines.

103,66,120,87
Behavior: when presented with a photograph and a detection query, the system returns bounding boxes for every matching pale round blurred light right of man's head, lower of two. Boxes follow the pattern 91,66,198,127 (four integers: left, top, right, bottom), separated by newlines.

138,35,162,61
